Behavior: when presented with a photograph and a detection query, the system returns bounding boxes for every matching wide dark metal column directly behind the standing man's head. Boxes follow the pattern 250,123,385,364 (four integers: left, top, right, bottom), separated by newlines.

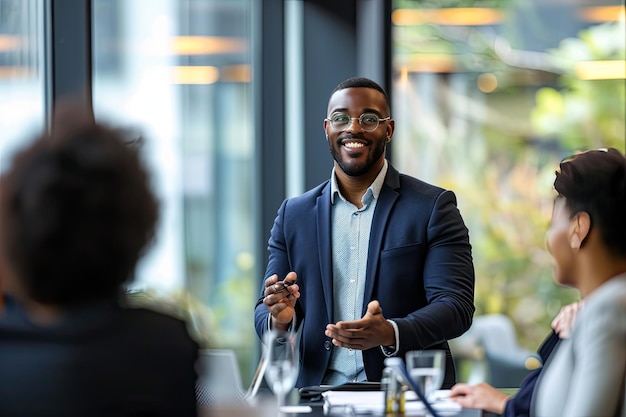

302,0,391,189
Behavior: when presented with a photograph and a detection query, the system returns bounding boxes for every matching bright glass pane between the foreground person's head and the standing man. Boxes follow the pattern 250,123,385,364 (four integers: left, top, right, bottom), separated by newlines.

93,0,257,380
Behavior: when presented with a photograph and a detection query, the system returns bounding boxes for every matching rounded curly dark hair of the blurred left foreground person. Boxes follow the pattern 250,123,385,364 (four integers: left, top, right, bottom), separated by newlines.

0,115,158,306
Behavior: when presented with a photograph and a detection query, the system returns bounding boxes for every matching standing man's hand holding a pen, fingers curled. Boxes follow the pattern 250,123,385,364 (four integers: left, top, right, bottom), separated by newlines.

263,272,300,330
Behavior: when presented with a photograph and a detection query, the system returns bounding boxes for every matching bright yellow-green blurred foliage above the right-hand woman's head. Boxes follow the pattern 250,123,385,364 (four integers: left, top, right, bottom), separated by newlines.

531,20,626,149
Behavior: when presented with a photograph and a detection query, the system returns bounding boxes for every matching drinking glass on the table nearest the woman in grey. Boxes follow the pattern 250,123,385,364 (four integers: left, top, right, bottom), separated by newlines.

406,350,446,400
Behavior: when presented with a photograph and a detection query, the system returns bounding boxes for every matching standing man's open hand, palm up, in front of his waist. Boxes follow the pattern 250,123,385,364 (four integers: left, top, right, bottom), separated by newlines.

324,300,395,350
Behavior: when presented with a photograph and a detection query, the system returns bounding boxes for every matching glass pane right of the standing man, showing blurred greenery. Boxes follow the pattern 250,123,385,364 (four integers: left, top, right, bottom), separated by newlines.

392,0,626,351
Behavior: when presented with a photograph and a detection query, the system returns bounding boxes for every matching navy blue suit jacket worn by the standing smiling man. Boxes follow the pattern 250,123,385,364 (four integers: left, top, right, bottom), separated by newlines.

255,164,474,387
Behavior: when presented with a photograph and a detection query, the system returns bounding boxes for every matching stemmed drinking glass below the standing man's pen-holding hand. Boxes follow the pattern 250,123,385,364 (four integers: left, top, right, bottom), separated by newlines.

264,330,299,413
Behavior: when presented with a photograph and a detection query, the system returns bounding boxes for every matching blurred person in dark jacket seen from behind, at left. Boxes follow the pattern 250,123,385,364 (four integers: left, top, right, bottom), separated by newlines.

0,112,198,417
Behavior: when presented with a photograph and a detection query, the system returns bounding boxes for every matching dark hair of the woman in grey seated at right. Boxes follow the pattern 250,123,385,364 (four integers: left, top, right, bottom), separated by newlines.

554,148,626,257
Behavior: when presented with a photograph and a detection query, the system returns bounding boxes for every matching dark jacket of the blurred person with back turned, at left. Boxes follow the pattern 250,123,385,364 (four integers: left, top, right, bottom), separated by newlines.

0,300,198,417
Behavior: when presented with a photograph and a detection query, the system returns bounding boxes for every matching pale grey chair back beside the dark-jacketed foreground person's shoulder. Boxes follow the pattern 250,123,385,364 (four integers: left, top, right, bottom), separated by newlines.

196,349,245,406
